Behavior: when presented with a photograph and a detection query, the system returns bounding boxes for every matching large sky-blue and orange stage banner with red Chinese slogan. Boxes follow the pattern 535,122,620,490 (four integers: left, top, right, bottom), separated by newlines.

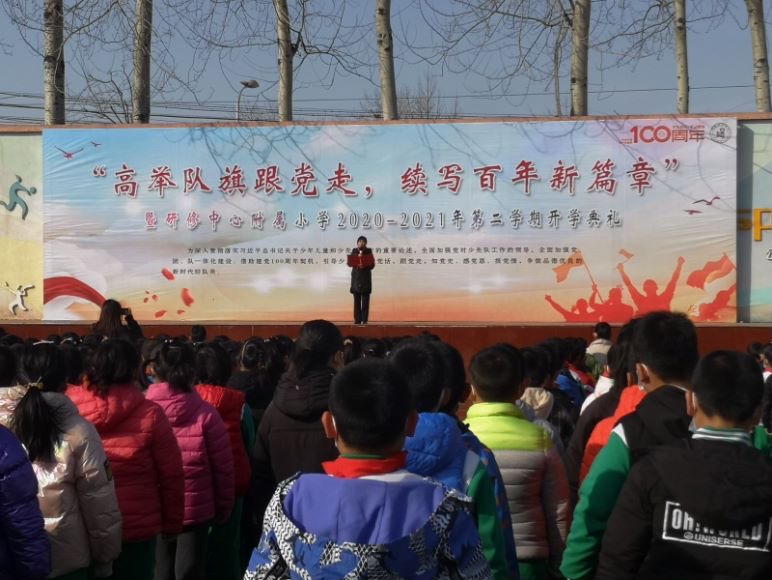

43,118,737,323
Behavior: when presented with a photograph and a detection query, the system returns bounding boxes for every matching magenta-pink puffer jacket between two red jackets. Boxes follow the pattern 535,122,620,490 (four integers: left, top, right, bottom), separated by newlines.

146,383,234,526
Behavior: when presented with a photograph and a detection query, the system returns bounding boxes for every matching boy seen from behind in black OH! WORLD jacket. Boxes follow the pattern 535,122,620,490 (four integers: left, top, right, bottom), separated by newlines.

596,351,772,580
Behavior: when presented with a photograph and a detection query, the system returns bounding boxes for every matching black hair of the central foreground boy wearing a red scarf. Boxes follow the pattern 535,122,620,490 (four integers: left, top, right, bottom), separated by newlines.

329,358,414,453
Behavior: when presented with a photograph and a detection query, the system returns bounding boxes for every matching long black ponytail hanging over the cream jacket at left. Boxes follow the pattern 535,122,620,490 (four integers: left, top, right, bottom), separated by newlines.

10,384,64,462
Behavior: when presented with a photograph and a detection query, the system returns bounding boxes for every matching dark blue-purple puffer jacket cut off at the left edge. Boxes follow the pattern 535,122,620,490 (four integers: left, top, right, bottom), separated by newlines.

0,426,51,580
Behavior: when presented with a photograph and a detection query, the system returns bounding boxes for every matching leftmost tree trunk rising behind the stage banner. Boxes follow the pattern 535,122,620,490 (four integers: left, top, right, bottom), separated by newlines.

43,0,65,125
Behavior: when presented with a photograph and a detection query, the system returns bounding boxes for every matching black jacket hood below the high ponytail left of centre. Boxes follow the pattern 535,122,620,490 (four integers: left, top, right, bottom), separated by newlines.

273,368,335,421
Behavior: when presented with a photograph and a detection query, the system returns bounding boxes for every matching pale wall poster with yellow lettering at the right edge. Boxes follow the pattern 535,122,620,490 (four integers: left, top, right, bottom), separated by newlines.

737,121,772,323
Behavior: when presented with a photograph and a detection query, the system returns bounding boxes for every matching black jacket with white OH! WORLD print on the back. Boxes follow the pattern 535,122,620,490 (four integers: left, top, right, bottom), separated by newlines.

596,439,772,580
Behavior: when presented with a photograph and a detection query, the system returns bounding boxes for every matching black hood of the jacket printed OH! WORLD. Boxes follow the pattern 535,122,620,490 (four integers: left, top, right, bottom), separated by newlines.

655,440,772,530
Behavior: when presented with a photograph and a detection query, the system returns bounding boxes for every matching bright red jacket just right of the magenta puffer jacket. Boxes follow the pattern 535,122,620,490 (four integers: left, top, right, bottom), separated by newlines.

196,385,252,497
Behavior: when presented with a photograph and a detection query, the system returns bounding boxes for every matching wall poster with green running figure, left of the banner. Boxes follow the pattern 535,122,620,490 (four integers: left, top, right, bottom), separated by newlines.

0,133,43,322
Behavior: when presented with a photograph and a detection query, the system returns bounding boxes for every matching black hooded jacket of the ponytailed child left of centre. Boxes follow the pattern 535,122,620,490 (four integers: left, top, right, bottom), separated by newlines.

252,368,338,532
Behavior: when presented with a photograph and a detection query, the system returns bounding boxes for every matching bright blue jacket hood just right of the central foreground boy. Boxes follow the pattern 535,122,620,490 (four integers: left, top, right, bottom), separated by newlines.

405,413,467,490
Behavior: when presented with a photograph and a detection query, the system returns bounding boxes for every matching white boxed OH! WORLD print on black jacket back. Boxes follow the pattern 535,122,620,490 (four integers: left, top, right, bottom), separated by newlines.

662,501,772,552
